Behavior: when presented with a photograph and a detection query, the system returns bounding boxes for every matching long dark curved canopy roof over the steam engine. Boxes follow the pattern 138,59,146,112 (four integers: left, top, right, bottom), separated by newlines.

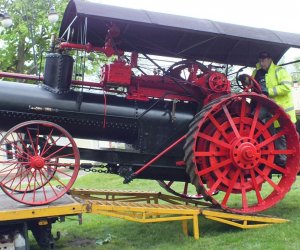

60,0,300,66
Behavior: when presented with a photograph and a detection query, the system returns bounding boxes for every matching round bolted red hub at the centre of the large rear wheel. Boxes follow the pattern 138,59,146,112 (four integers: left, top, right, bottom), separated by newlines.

231,137,261,169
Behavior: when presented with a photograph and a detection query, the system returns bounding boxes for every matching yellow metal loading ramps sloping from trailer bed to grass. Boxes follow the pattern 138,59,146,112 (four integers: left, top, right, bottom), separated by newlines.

71,189,288,239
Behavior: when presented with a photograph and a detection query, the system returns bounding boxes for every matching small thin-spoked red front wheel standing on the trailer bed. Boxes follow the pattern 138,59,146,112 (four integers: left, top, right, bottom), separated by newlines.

0,121,80,205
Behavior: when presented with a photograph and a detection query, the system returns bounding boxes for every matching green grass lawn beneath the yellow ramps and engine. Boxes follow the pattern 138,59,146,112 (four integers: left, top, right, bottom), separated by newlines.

31,174,300,250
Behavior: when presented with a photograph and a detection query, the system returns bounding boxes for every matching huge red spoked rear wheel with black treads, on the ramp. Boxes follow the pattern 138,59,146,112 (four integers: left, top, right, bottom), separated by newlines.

185,93,299,213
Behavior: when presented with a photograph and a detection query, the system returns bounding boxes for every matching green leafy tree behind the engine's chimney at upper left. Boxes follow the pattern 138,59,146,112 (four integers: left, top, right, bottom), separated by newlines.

0,0,68,74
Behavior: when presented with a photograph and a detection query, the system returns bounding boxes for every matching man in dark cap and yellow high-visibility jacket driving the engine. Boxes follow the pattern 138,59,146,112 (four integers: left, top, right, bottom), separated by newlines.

252,52,296,166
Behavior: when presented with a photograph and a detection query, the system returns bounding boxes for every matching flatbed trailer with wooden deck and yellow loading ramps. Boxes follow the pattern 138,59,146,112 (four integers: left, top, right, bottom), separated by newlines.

0,189,288,250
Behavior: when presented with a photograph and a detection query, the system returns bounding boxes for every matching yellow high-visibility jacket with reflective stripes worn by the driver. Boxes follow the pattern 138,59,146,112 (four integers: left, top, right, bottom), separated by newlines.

252,62,296,127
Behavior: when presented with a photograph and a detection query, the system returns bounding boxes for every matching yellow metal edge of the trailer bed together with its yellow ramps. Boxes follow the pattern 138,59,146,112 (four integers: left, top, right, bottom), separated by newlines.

0,189,288,239
